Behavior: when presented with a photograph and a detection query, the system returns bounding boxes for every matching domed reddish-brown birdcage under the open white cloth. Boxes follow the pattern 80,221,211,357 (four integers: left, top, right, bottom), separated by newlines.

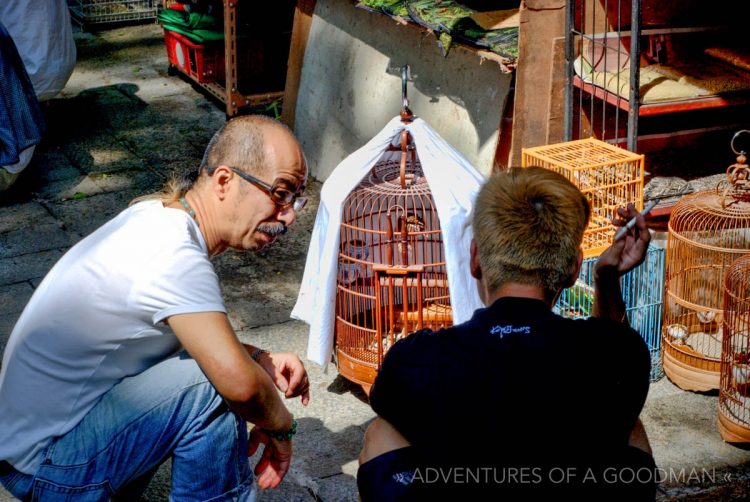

335,130,453,391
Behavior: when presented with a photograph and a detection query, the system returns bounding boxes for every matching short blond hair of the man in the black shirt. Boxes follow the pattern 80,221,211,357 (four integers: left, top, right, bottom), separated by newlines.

473,167,590,296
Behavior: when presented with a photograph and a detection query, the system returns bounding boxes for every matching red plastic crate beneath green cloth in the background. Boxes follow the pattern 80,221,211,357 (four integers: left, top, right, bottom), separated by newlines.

164,30,224,83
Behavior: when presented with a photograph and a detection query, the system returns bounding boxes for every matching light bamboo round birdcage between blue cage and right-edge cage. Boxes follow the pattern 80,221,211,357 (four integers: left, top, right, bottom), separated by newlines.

662,136,750,391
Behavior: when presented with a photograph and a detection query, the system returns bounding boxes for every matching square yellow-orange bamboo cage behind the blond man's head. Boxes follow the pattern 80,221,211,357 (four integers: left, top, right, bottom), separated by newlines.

521,138,644,257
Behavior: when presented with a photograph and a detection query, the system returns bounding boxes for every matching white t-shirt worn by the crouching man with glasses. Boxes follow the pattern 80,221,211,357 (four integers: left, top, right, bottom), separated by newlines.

0,201,226,474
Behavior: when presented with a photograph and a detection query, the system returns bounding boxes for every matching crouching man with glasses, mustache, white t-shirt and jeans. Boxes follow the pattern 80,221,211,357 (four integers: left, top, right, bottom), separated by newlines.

0,116,309,501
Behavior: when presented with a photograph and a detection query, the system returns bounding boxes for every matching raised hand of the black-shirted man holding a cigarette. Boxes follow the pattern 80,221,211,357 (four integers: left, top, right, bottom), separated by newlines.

594,204,651,277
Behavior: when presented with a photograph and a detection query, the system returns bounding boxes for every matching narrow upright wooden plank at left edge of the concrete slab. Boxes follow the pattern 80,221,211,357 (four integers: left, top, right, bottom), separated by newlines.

281,0,316,129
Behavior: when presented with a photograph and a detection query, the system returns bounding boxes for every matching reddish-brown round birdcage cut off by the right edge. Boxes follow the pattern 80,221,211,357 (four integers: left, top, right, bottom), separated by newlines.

718,255,750,443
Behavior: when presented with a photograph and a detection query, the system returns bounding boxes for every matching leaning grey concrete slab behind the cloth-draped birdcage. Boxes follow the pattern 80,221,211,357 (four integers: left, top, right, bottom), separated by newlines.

295,0,511,180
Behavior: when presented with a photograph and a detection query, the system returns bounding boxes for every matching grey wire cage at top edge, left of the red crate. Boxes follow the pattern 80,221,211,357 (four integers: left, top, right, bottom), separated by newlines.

68,0,161,25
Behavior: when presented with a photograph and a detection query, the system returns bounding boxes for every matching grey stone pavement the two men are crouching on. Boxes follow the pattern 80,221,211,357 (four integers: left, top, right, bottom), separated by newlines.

0,20,750,502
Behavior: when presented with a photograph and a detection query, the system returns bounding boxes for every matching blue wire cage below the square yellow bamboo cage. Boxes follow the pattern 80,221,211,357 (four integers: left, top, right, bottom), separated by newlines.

555,244,664,382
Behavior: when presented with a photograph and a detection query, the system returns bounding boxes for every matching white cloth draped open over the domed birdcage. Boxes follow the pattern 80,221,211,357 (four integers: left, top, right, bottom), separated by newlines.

291,117,483,365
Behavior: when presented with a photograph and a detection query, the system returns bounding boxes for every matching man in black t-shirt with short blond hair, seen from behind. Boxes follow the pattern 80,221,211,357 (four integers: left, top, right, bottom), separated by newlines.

358,167,655,502
